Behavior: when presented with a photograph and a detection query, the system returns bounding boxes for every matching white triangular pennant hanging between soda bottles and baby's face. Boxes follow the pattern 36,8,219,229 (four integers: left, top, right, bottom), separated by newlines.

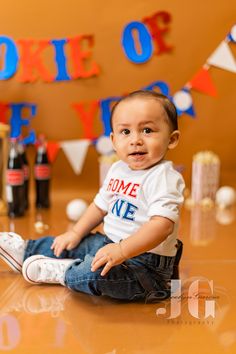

60,139,90,174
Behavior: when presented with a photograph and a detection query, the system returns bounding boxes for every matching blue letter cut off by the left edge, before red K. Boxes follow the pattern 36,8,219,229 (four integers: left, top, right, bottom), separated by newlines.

0,37,19,80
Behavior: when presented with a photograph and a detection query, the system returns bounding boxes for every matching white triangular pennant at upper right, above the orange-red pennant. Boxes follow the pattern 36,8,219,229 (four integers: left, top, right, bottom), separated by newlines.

207,41,236,73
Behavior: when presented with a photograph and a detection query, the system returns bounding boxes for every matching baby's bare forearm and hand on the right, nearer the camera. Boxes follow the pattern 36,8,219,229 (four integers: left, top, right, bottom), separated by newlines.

92,216,174,275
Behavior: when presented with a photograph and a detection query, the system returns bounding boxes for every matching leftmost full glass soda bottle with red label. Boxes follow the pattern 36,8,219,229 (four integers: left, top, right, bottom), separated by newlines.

6,138,25,217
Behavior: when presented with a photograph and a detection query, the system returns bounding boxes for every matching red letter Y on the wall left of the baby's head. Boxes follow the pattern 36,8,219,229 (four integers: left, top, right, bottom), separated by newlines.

72,101,98,139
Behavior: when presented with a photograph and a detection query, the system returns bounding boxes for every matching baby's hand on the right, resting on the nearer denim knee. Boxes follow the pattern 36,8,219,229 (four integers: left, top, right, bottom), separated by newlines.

91,243,125,276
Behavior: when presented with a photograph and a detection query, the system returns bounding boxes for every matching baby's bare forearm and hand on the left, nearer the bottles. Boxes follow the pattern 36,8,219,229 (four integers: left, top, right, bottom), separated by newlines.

51,203,106,257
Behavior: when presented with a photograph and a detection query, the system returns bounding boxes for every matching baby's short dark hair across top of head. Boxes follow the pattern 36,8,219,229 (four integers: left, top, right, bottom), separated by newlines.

110,90,178,131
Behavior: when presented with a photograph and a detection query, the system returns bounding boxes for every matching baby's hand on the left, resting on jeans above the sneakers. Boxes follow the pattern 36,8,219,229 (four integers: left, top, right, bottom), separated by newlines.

51,230,80,257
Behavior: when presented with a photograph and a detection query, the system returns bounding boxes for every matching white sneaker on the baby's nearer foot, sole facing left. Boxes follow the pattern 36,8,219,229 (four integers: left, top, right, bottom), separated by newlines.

22,255,74,285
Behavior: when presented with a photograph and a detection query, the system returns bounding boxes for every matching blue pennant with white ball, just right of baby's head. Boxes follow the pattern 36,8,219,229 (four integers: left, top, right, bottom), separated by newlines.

172,87,195,117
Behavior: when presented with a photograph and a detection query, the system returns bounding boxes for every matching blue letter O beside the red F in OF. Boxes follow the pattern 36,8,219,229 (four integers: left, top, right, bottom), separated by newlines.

122,22,153,64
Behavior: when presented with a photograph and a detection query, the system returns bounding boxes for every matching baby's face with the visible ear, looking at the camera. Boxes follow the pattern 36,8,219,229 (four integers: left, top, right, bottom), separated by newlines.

111,97,179,170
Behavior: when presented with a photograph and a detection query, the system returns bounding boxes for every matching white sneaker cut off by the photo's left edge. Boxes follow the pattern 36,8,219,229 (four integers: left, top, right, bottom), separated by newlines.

0,232,26,273
